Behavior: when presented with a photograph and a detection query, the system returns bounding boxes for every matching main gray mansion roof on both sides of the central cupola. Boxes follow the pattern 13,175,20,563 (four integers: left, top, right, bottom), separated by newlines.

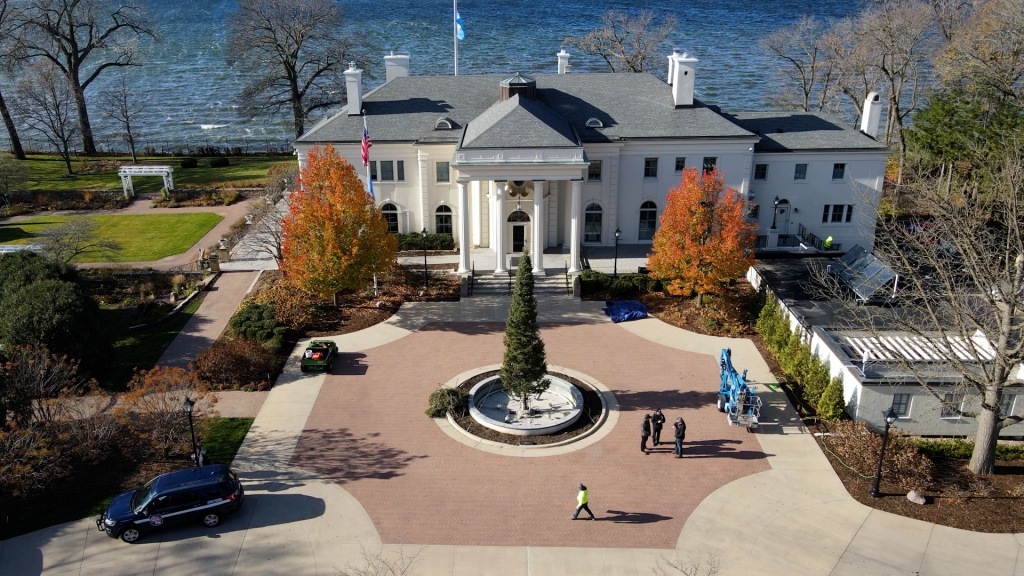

297,73,754,143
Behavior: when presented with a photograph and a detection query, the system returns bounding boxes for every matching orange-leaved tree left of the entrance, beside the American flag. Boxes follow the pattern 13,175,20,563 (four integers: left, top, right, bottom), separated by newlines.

281,145,398,305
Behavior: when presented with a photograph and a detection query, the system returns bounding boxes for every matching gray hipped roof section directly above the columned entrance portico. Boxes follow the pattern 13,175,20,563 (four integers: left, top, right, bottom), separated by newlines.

461,94,582,149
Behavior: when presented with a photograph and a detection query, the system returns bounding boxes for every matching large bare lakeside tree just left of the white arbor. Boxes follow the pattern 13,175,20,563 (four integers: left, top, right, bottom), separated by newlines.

17,0,157,155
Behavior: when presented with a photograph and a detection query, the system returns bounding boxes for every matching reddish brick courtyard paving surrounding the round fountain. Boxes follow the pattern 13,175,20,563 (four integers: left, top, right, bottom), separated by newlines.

293,323,768,548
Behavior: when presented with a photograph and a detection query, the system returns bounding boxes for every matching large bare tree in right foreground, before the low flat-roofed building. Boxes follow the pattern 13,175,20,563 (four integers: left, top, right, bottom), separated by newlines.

817,142,1024,475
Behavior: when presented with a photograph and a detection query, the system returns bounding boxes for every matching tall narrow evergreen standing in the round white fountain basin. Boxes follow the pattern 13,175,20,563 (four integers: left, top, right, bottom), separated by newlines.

501,250,550,414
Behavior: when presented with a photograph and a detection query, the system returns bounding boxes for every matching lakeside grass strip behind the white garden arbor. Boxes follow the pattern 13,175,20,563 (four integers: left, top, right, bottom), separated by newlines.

25,155,295,194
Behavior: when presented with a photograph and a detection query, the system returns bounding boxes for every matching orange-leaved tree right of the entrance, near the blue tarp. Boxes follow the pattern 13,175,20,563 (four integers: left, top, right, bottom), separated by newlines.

647,168,757,307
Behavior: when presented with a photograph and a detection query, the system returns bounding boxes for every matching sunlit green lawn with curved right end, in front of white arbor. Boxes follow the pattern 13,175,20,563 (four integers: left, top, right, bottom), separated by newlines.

0,212,223,262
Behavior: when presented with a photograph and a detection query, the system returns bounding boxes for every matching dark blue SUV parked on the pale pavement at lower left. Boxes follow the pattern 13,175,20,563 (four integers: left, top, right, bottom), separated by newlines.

96,464,245,542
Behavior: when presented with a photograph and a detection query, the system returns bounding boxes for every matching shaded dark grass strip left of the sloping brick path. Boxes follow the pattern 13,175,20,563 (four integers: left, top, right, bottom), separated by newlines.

102,296,203,392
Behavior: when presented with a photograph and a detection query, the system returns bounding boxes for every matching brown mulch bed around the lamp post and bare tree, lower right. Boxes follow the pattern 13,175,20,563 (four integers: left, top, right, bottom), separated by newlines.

816,430,1024,533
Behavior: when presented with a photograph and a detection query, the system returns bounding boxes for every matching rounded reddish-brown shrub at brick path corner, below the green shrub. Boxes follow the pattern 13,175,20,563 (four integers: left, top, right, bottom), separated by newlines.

196,337,278,390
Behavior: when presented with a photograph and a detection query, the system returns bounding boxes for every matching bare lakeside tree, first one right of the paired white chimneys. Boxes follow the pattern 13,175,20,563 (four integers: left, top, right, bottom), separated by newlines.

761,16,838,112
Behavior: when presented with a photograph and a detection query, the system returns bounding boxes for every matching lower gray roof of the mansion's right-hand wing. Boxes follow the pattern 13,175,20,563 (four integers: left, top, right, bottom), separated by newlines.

725,112,888,152
